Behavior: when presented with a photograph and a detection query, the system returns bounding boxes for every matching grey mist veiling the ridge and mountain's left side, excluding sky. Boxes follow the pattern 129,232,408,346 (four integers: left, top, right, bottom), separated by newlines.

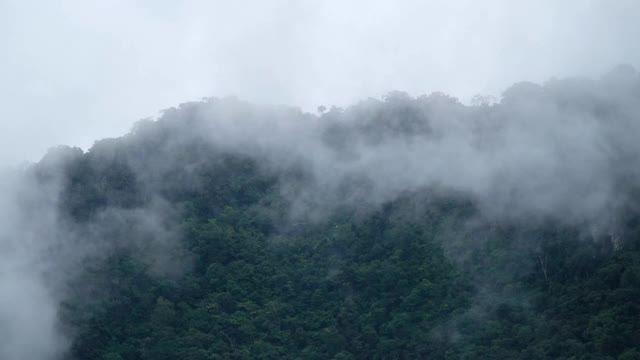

0,66,640,360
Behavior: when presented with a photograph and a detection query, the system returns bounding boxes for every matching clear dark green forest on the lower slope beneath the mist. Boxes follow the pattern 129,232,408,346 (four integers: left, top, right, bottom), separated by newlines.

62,153,640,359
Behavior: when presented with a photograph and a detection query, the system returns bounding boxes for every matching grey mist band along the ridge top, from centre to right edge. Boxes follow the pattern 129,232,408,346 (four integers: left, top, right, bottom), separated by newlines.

139,66,640,222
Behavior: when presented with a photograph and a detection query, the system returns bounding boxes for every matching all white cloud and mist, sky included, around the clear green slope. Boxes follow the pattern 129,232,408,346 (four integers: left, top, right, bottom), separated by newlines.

0,0,640,360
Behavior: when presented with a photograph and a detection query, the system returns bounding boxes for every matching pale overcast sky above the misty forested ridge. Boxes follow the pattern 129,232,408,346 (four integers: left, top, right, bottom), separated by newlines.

0,0,640,164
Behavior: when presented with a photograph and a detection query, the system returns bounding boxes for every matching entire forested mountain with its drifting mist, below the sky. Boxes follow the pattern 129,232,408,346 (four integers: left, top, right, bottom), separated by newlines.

0,66,640,360
